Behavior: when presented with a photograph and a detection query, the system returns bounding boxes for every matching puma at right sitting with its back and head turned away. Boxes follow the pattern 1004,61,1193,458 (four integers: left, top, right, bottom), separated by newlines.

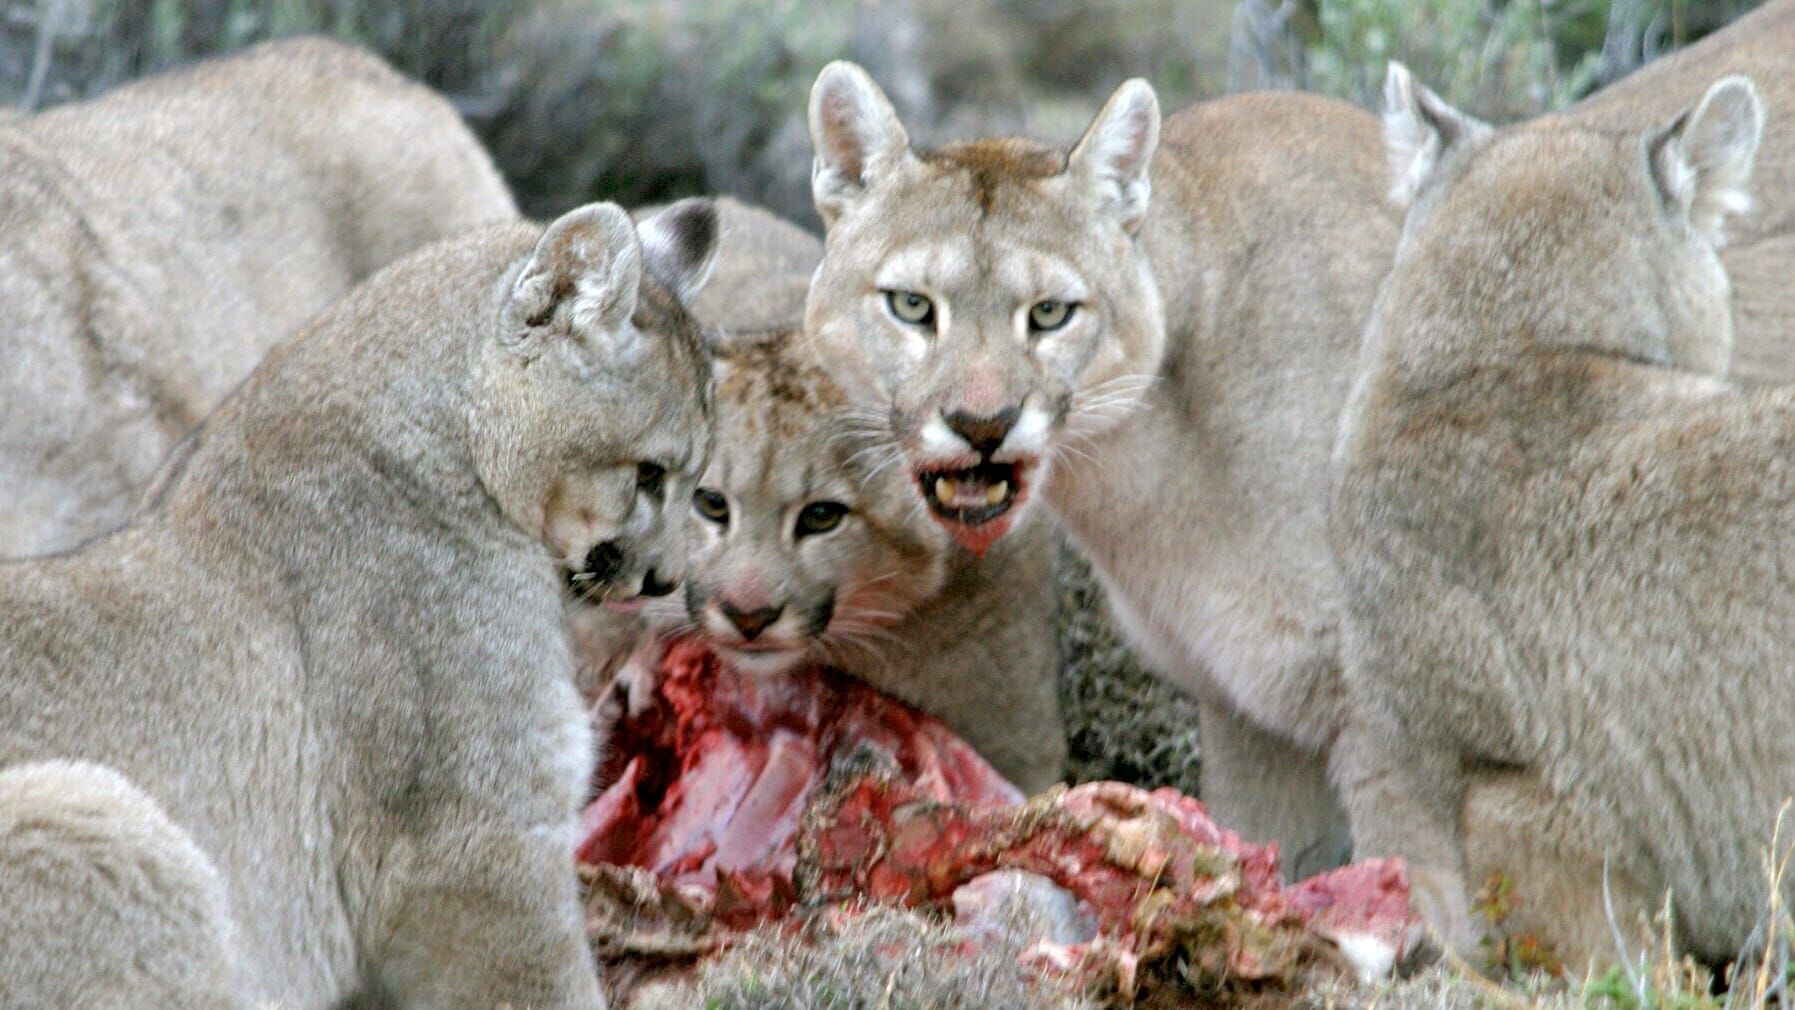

1330,66,1795,960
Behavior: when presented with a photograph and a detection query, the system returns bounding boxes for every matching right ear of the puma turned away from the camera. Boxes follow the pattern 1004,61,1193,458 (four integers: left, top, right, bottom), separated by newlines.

1648,75,1764,246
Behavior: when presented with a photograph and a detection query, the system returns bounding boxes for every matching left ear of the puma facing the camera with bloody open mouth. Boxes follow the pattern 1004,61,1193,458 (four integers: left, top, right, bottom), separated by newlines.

810,59,910,226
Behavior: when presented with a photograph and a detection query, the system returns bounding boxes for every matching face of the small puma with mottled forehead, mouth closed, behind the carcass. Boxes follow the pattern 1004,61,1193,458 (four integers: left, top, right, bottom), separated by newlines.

652,334,951,675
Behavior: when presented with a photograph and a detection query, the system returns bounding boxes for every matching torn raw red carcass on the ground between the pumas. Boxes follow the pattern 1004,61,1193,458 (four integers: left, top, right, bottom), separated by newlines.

580,642,1414,1003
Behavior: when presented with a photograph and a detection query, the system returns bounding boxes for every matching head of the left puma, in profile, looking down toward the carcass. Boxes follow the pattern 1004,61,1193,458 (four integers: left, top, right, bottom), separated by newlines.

472,201,716,610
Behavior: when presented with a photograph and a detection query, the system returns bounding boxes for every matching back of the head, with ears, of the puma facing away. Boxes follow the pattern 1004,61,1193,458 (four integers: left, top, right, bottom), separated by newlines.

1386,66,1763,375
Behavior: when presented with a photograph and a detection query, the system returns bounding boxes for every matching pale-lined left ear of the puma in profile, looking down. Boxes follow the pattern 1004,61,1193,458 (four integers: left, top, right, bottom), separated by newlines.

504,203,643,343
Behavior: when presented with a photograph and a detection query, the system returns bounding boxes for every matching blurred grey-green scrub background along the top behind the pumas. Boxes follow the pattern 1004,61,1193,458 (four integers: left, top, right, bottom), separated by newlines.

0,0,1756,226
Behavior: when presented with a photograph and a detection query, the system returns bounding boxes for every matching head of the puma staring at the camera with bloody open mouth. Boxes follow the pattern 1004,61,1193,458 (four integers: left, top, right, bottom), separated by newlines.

806,63,1165,553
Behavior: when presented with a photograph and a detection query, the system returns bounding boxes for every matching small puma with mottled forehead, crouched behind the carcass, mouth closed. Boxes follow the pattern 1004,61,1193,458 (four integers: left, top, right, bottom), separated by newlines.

671,327,1066,793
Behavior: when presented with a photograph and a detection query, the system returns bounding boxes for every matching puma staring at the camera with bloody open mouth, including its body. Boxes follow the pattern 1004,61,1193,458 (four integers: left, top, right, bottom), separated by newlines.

806,63,1398,872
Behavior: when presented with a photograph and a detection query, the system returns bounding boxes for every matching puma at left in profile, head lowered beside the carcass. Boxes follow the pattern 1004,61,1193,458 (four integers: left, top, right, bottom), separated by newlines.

0,201,716,1010
